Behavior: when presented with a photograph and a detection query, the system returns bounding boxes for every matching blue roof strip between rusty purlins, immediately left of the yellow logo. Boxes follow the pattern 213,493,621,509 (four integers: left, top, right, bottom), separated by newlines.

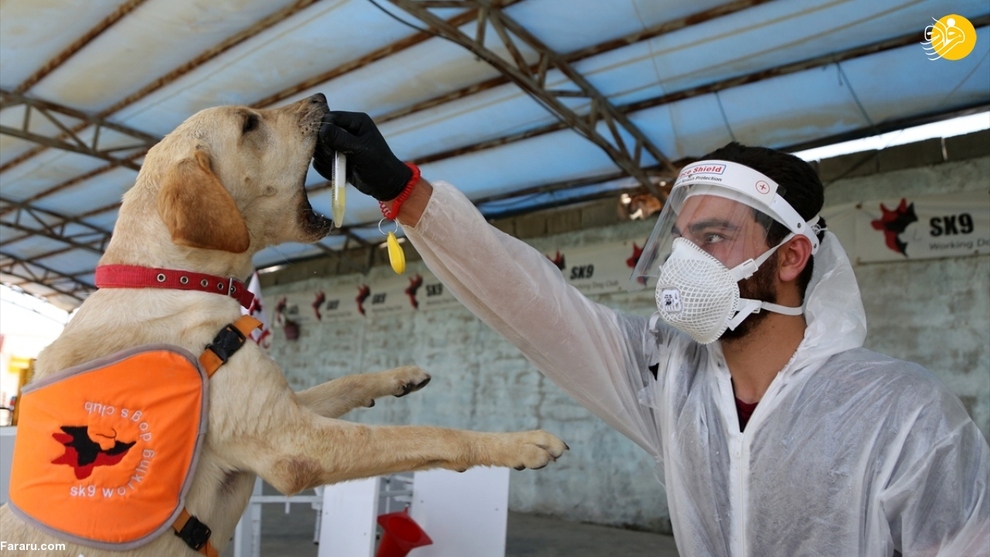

575,0,978,104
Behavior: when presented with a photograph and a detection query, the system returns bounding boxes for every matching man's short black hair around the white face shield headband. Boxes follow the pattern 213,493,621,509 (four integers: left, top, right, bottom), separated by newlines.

703,141,825,300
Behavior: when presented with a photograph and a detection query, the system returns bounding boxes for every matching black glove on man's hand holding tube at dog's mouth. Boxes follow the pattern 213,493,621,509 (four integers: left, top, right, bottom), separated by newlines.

313,111,412,201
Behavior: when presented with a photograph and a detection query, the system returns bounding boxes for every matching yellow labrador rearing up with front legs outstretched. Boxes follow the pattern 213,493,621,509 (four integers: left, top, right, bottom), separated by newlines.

0,94,567,557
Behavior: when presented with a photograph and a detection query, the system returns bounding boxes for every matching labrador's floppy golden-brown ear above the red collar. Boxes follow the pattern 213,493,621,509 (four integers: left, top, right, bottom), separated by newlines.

158,150,251,253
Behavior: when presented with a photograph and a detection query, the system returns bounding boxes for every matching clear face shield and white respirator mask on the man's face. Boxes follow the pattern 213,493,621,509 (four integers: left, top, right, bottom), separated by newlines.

630,161,818,344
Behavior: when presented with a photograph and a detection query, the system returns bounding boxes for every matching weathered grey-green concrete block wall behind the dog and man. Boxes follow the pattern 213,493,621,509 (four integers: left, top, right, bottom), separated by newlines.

262,132,990,533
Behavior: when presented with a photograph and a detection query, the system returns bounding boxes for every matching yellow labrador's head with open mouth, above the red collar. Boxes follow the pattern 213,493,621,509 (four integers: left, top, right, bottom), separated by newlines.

108,94,331,268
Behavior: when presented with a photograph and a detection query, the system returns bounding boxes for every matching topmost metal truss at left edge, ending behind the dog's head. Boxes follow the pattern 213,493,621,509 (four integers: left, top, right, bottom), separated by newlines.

0,90,159,170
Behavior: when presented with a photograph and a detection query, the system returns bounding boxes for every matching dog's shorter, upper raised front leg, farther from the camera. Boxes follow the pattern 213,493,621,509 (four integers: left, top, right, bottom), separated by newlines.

296,366,430,418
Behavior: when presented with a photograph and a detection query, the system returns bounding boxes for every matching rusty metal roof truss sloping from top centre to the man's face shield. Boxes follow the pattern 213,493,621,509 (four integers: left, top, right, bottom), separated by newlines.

389,0,675,197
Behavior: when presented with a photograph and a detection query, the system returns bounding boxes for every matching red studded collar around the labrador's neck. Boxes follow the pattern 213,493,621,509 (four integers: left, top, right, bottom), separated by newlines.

96,265,254,309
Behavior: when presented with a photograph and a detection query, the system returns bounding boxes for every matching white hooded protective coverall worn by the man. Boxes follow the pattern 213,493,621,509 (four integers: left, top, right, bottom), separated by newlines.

405,182,990,557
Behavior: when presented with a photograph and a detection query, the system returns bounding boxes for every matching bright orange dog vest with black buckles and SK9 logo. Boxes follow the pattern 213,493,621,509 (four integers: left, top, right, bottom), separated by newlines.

10,316,260,554
